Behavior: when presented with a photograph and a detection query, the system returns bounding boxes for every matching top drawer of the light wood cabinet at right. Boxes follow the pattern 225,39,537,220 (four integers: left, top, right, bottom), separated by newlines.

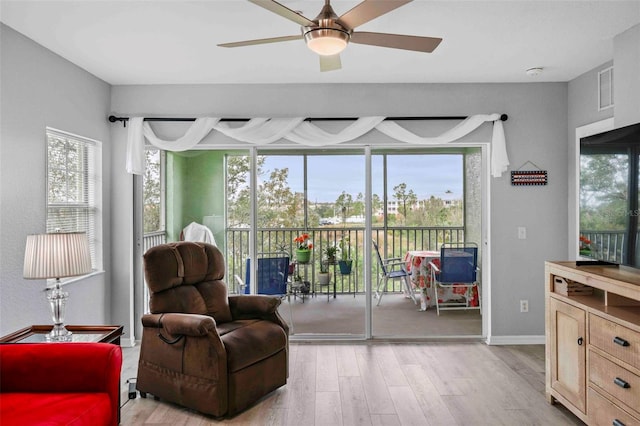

589,314,640,369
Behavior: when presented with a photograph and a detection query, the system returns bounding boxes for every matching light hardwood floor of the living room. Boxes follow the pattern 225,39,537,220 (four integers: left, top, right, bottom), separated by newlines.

121,342,583,426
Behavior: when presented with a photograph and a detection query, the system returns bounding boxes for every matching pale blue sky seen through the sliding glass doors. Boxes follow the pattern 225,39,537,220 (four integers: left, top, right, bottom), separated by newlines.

263,154,463,202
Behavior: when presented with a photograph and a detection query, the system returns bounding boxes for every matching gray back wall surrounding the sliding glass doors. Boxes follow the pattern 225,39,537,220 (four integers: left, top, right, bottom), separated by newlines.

112,83,567,336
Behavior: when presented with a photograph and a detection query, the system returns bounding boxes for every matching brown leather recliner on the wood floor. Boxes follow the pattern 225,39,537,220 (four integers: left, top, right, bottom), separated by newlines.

137,241,289,417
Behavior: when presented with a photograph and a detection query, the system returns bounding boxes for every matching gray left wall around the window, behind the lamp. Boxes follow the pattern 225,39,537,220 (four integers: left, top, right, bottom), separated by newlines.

0,25,111,335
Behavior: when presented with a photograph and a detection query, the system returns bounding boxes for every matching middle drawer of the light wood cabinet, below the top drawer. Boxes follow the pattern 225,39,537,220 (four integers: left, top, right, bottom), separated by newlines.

588,350,640,410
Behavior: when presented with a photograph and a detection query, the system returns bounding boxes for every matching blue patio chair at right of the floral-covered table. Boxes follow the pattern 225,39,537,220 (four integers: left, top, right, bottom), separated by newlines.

429,243,482,315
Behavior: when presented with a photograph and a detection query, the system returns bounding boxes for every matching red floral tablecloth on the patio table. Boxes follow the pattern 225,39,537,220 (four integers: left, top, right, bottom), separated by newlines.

404,250,477,310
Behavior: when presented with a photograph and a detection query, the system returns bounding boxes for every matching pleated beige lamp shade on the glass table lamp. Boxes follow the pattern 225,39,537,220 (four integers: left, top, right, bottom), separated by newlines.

23,232,91,280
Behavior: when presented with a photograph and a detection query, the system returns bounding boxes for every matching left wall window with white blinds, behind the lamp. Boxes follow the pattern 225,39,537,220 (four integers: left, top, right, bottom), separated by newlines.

47,128,102,270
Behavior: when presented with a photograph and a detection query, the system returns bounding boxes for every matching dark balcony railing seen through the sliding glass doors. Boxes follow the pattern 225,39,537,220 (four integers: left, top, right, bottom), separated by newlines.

144,226,464,294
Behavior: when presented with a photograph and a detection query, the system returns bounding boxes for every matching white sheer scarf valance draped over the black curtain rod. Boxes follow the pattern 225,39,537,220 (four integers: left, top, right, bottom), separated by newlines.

126,114,509,177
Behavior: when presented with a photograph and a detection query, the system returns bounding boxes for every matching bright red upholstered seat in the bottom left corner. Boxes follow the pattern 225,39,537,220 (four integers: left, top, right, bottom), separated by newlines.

0,343,122,426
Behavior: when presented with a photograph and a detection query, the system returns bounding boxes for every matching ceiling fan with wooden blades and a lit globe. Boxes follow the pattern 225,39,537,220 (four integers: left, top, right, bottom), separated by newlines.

218,0,442,71
